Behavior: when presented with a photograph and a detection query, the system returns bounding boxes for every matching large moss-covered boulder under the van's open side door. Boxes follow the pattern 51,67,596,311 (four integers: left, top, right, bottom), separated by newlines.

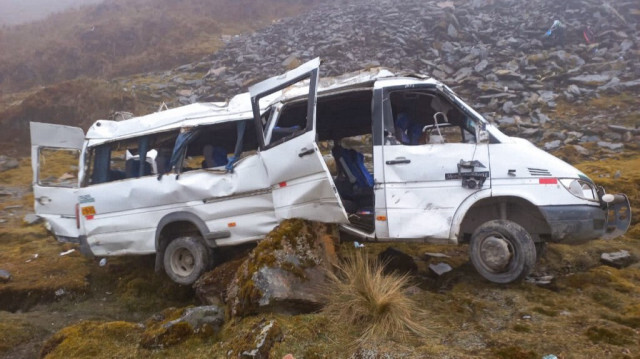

227,219,337,316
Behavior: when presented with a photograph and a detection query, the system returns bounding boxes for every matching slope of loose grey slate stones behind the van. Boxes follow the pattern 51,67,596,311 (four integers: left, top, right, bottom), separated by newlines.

122,0,640,152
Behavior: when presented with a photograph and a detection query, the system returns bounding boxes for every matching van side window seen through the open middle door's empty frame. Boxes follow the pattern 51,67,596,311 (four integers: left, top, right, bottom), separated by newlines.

265,101,311,147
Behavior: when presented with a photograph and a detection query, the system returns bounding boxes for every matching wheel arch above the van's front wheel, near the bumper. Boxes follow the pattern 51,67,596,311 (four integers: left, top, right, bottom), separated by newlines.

451,196,551,242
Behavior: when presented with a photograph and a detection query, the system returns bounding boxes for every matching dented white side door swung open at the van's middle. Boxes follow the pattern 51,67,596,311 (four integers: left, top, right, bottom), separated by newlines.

249,58,348,223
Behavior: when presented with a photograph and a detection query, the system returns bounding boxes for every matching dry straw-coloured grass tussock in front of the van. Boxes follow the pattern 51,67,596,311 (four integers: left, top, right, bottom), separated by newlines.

323,252,427,344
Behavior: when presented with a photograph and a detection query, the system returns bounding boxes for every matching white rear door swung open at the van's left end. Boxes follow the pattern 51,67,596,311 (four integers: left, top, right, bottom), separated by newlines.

30,122,84,242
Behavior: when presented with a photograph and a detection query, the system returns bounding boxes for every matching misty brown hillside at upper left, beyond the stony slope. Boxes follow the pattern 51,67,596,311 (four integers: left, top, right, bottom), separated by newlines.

0,0,313,93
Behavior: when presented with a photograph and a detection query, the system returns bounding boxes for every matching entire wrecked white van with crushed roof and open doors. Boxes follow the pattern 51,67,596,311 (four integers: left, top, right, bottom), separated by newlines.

31,59,631,284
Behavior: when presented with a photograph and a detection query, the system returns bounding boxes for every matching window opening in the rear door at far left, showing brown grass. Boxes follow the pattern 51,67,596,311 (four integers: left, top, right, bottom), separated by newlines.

38,147,80,187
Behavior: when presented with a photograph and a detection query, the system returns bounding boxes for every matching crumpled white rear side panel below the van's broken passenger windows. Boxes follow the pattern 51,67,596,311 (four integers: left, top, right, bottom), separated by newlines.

78,155,276,255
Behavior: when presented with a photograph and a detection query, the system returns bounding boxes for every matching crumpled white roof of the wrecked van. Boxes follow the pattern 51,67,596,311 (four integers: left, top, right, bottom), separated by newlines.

86,67,437,146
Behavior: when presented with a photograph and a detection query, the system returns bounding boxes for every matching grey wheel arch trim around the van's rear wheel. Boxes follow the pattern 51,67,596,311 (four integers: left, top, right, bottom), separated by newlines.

155,212,209,272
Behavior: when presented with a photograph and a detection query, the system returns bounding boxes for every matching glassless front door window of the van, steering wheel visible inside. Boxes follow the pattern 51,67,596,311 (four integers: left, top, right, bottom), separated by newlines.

387,91,476,146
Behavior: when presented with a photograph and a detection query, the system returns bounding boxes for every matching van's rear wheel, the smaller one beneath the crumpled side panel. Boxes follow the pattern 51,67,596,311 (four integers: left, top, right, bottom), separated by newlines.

164,237,210,285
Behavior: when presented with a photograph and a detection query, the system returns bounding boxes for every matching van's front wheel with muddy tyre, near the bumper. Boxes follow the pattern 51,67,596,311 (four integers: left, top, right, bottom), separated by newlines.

469,220,536,284
